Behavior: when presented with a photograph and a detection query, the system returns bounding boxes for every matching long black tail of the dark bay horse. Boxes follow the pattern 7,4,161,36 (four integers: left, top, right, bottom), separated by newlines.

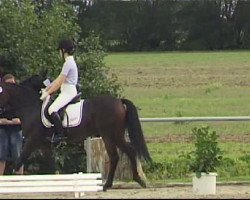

121,99,152,162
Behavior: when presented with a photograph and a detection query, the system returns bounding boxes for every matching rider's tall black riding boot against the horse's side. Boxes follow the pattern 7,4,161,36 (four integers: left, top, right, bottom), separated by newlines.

50,112,65,143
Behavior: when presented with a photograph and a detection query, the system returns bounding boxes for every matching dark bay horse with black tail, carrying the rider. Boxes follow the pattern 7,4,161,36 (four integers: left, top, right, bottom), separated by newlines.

0,80,152,190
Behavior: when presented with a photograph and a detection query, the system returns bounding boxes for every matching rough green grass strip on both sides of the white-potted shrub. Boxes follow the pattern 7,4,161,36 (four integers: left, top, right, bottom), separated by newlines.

143,142,250,183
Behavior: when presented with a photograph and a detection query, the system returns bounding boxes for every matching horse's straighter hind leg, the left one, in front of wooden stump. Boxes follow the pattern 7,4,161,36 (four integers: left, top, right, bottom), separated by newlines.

102,138,119,191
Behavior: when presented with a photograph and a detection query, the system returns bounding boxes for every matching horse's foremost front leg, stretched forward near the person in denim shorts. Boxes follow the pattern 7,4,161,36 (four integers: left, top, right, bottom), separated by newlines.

15,138,36,171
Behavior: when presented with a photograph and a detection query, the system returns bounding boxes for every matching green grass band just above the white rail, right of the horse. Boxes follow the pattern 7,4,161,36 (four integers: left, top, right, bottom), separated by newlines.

126,86,250,117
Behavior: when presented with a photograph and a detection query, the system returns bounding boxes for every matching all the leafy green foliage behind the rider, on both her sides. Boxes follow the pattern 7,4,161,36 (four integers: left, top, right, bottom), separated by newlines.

0,0,122,172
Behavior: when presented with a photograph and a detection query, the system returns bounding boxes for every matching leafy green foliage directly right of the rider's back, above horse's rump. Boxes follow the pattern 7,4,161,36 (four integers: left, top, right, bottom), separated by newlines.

78,32,123,98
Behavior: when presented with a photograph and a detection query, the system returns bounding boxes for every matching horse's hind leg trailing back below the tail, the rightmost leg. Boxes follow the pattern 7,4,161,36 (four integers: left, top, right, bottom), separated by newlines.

117,138,146,188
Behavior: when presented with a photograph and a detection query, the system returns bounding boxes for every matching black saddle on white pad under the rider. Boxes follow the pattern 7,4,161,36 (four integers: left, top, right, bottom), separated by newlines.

44,92,82,122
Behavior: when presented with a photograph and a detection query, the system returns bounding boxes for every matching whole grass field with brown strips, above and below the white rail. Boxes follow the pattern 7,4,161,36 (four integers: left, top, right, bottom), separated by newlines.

105,51,250,180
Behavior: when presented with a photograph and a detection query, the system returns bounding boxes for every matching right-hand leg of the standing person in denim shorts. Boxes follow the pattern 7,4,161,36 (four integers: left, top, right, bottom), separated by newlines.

9,127,24,175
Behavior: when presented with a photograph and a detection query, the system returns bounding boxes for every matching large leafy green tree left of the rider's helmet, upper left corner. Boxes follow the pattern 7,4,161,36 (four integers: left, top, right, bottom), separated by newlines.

0,0,79,77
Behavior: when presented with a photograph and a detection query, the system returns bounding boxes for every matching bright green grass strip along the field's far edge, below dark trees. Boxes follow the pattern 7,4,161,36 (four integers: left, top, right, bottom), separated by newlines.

105,51,249,69
